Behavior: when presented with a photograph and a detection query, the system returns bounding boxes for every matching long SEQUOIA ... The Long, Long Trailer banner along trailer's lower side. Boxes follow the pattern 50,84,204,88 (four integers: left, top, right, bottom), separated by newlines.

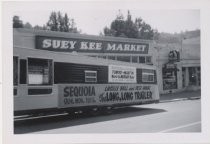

58,84,157,108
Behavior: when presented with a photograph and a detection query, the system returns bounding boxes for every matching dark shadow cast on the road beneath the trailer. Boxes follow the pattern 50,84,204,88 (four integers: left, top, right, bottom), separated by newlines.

14,107,166,134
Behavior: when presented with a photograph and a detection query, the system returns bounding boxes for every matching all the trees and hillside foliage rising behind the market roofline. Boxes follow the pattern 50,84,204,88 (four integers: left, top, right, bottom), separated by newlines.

13,11,200,43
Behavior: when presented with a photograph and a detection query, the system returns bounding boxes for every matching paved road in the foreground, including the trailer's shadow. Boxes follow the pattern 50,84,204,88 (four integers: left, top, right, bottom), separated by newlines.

14,99,201,134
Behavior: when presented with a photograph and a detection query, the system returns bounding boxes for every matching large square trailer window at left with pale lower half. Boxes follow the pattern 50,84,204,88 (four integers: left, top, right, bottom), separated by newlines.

28,58,52,85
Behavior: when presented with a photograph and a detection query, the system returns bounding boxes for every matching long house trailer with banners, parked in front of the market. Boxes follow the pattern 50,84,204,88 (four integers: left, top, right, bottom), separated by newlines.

13,28,159,115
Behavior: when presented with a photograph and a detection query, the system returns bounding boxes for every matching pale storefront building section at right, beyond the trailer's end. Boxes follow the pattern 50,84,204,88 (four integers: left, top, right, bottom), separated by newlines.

154,37,201,94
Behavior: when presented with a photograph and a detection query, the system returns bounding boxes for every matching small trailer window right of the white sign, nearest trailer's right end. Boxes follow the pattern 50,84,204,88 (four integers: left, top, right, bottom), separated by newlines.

142,69,155,82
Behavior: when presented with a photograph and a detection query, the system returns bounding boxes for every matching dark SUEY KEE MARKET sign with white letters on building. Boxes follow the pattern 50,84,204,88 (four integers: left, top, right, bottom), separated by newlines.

36,36,149,54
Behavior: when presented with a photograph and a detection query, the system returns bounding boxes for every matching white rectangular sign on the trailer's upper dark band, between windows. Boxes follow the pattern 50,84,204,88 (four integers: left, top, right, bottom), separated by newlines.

109,65,136,83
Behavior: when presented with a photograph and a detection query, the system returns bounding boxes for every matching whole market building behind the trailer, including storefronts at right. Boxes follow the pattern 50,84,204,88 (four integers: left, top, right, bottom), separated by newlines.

13,28,201,94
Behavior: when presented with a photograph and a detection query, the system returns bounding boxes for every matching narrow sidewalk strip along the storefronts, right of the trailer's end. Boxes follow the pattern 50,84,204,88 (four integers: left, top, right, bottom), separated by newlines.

160,90,201,103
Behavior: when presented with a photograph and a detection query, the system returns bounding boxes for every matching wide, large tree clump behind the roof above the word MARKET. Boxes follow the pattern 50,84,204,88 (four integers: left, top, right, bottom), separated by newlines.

104,11,158,39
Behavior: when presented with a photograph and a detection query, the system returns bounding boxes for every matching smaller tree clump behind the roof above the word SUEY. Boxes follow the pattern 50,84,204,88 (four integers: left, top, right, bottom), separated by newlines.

47,11,79,33
